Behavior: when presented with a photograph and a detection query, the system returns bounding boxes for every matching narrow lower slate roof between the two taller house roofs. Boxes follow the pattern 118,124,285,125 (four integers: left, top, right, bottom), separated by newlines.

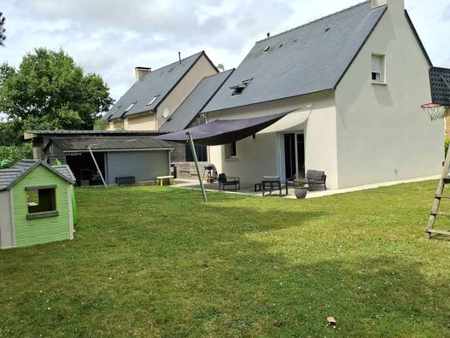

159,69,234,132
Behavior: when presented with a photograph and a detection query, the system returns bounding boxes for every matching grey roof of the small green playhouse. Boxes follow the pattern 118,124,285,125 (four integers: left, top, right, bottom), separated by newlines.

0,160,75,191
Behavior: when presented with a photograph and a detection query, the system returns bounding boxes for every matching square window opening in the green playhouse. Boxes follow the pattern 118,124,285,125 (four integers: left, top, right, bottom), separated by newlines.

26,186,58,219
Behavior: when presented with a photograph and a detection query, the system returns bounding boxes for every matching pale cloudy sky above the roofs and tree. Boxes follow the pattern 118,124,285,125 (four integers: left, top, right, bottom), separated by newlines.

0,0,450,100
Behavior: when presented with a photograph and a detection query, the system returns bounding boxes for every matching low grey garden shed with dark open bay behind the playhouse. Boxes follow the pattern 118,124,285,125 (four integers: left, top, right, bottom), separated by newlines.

25,131,173,185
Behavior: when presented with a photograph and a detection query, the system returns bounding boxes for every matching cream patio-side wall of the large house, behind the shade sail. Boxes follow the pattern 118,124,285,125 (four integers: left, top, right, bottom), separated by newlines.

208,93,337,188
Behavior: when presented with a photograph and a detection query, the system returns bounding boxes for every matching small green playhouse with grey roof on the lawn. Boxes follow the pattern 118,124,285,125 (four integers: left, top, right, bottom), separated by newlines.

0,160,77,249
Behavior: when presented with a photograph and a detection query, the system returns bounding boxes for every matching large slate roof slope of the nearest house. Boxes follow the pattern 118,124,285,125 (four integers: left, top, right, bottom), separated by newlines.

204,1,387,112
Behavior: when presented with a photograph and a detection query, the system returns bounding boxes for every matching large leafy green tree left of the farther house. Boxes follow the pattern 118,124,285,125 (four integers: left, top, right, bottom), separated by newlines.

0,48,113,129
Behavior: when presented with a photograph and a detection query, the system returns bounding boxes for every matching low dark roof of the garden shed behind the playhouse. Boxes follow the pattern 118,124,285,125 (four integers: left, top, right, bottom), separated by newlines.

51,136,173,151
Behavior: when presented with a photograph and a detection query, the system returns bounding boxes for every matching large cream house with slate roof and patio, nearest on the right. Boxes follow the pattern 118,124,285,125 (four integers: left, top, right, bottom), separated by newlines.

203,0,444,188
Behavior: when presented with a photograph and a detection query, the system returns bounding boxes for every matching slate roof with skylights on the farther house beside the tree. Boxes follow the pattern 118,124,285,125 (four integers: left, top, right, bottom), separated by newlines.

105,52,206,119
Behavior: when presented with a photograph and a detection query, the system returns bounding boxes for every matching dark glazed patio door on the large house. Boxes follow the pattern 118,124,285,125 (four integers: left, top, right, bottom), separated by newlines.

284,134,305,180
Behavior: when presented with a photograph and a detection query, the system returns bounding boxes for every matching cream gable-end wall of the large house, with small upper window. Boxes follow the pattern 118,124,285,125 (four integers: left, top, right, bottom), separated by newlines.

335,1,444,188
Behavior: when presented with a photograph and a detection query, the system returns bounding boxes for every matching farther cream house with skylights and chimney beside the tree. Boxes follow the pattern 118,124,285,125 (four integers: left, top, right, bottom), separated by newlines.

105,51,218,131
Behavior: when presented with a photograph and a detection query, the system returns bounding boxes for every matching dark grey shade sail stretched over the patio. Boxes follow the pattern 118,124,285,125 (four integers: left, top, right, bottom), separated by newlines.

155,113,288,146
